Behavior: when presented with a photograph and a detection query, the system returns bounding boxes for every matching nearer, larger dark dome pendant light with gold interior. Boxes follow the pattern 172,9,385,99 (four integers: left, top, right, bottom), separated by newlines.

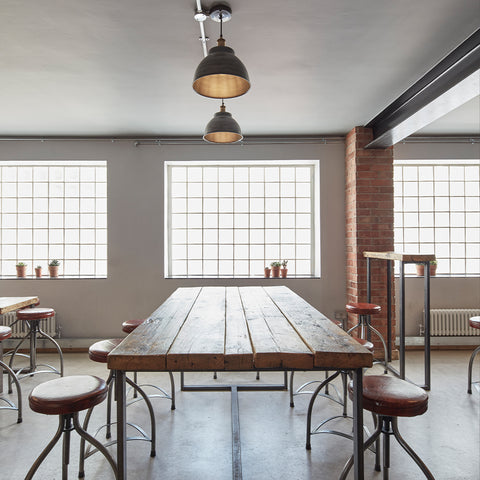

193,5,250,98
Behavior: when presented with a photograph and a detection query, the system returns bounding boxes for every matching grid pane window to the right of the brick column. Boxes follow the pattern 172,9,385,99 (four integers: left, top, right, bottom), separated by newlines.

394,160,480,276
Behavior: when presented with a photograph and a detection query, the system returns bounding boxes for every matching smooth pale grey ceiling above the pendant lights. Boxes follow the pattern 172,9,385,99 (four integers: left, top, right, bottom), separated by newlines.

0,0,480,137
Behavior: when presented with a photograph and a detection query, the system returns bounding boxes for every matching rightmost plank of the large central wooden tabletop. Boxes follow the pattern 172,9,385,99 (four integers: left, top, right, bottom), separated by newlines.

265,287,373,369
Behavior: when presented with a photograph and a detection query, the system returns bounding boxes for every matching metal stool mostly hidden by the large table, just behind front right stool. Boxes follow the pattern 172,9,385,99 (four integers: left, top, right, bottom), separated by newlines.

305,338,374,450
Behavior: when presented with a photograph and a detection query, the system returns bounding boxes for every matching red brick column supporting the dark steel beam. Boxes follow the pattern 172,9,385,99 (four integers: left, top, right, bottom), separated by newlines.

345,127,395,358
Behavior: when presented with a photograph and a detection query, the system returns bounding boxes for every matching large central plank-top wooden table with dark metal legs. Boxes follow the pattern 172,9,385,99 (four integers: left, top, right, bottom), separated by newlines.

108,286,372,480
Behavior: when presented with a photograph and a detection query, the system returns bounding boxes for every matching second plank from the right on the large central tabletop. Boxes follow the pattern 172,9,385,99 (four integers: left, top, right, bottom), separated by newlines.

239,287,313,369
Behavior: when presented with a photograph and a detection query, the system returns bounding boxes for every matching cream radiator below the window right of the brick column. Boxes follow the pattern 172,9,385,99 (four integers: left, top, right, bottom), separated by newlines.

430,308,480,337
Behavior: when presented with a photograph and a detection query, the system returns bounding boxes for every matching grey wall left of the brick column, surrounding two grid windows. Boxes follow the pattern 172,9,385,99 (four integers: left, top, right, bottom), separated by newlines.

0,140,345,339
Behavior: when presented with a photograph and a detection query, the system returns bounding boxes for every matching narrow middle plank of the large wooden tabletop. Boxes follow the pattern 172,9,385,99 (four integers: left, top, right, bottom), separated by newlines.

225,287,253,370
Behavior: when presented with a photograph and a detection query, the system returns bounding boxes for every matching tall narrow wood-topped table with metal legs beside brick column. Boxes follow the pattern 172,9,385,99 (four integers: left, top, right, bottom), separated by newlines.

363,252,435,390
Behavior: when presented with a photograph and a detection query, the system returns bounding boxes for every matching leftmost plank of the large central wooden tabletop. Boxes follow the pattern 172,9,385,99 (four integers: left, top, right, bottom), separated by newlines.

108,287,201,371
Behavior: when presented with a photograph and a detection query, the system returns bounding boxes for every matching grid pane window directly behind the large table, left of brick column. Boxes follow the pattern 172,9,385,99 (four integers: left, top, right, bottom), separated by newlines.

165,161,319,277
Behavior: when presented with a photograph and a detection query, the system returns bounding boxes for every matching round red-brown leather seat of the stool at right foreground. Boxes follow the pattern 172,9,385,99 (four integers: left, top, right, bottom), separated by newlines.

348,375,428,417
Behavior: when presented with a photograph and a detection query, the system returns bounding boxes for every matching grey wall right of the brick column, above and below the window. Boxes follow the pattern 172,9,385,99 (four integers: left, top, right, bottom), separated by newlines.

394,143,480,336
